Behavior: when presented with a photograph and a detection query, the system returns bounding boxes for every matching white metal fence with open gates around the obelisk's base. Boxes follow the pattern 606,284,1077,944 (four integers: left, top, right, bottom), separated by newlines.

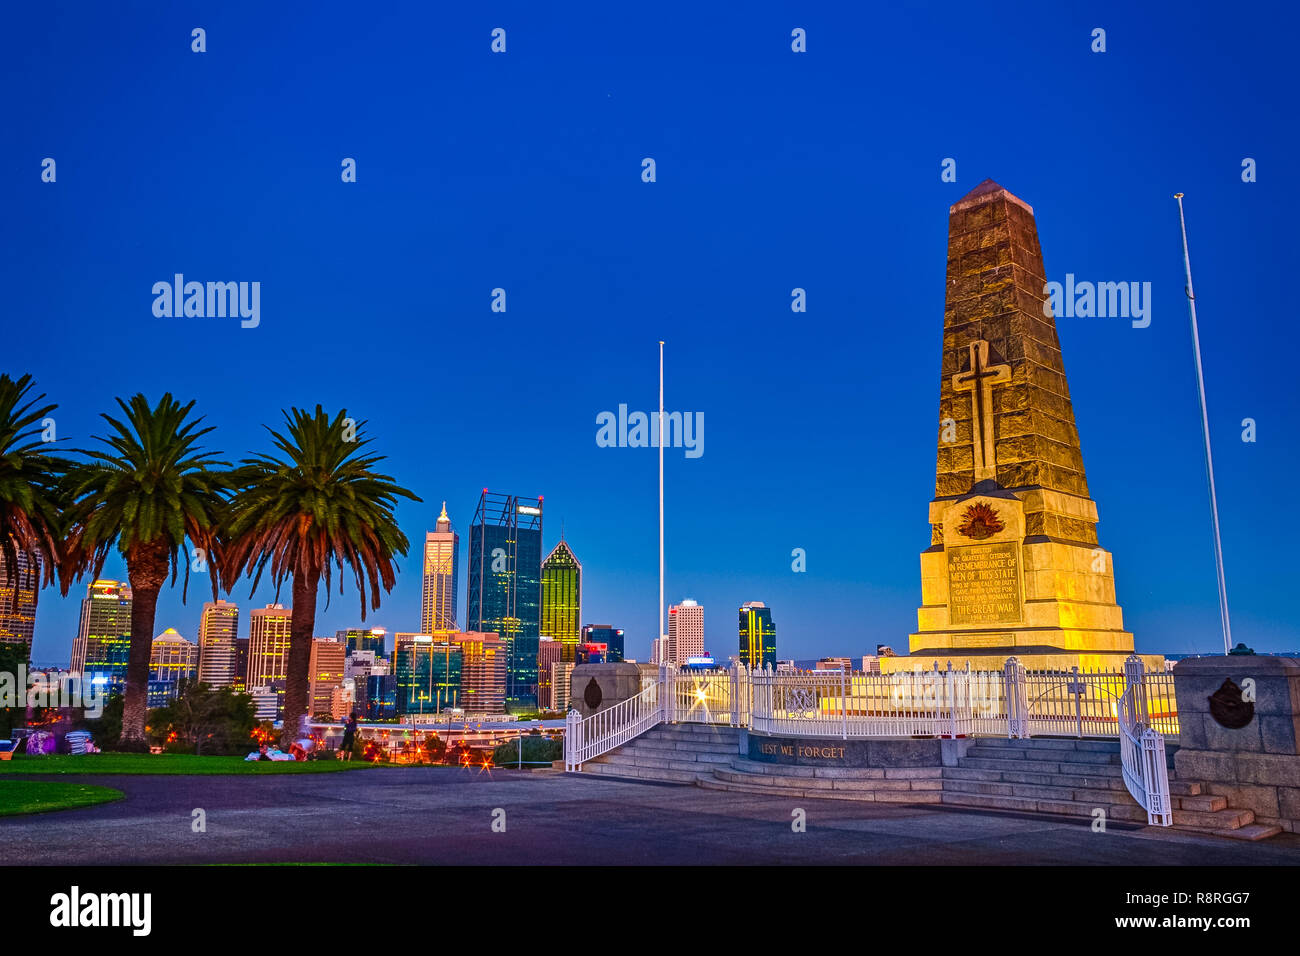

564,656,1178,826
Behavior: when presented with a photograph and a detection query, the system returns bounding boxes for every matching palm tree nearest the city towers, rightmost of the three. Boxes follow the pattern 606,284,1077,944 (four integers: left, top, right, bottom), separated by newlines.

221,405,420,749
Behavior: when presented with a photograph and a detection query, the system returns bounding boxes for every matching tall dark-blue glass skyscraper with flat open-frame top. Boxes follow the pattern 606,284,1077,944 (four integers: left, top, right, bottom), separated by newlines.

465,488,542,709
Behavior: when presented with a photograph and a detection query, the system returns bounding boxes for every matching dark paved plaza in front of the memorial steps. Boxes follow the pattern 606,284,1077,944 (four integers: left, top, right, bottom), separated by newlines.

0,767,1300,866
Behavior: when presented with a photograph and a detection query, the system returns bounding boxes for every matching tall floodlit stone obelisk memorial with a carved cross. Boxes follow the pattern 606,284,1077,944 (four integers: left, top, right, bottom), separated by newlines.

881,179,1164,671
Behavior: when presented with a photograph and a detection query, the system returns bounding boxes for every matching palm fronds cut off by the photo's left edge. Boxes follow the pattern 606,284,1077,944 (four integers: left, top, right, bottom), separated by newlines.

0,375,69,642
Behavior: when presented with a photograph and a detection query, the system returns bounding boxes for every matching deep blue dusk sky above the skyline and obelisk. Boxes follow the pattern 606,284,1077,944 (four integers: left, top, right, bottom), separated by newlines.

0,3,1300,662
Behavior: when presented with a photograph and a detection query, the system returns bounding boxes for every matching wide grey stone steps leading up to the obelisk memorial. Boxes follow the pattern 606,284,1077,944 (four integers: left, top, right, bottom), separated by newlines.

582,723,1281,840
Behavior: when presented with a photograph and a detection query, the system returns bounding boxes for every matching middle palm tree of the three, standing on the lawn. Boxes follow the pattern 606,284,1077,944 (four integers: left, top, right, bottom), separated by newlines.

62,393,229,749
